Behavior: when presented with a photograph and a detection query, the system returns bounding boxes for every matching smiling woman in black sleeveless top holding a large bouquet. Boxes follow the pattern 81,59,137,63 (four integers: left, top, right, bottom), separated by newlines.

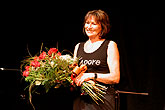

73,10,120,110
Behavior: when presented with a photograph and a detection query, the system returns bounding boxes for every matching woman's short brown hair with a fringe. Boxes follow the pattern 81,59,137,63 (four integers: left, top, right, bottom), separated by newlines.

83,10,110,38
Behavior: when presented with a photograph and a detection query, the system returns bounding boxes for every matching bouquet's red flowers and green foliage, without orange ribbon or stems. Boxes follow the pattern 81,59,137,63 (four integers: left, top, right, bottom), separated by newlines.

21,48,78,109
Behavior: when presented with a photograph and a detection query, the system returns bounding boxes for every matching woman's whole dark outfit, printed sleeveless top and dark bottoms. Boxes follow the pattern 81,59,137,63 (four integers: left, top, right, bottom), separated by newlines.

73,40,115,110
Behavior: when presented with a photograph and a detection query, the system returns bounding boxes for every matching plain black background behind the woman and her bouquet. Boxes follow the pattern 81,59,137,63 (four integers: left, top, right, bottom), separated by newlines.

0,2,165,110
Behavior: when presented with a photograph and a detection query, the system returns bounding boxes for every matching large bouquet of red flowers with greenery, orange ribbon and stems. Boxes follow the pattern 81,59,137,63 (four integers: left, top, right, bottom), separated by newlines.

21,48,107,108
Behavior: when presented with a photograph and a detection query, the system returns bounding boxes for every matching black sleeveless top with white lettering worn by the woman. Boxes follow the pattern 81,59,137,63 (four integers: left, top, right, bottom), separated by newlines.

77,40,110,73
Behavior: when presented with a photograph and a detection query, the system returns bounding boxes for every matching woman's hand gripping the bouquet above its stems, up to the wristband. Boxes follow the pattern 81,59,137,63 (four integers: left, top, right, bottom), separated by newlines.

75,73,94,86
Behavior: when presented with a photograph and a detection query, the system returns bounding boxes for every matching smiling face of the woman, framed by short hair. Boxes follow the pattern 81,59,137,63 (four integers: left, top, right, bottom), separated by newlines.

84,16,102,37
